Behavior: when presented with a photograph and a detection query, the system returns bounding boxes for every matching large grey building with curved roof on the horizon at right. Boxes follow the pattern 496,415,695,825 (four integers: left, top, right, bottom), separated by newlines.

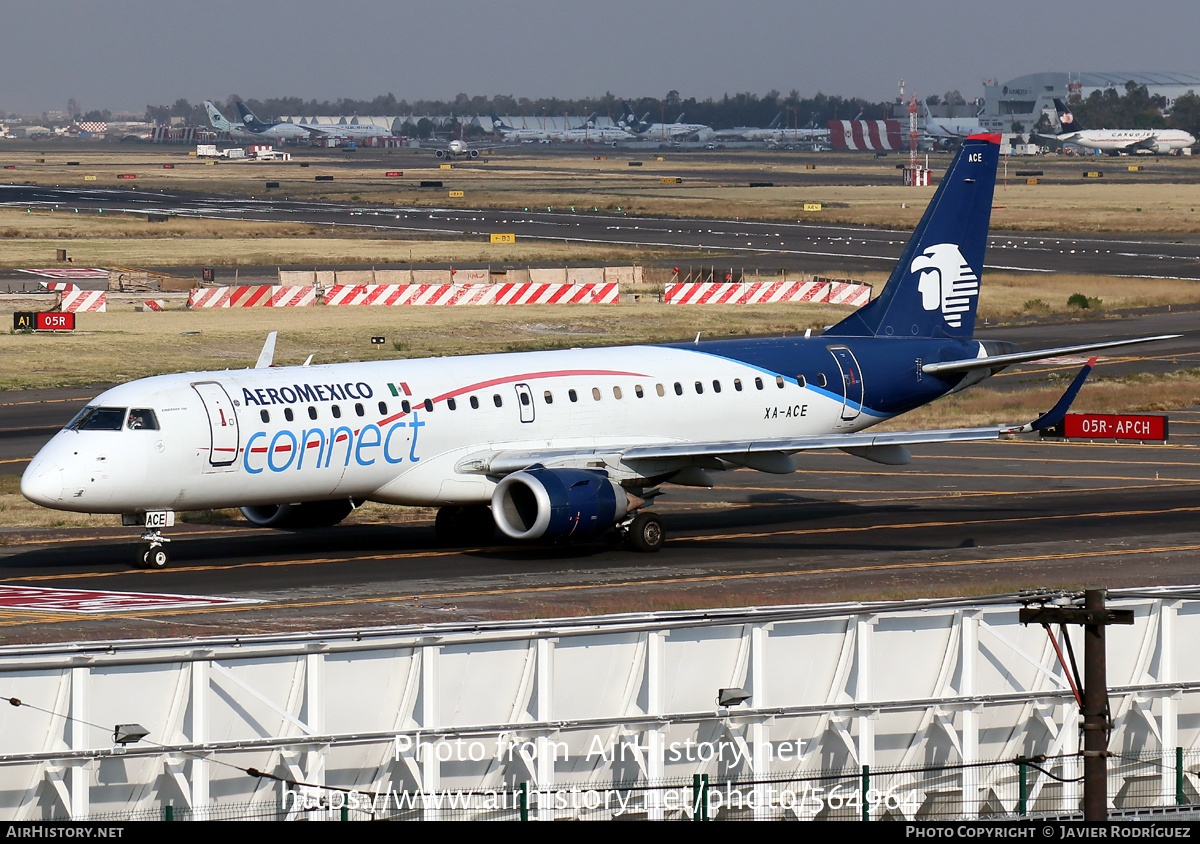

979,71,1200,133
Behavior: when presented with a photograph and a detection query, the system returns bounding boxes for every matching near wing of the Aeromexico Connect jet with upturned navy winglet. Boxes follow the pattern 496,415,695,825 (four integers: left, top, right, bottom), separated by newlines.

457,358,1096,475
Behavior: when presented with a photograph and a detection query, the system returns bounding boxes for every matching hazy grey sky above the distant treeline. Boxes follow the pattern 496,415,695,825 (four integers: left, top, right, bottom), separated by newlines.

9,0,1200,113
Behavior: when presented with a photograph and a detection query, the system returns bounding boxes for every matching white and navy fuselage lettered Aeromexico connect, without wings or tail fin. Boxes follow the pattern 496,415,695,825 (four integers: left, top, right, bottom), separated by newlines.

22,335,982,513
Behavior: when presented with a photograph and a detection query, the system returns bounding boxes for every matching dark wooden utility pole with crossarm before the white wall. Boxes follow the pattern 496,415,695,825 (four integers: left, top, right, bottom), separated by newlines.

1019,589,1133,824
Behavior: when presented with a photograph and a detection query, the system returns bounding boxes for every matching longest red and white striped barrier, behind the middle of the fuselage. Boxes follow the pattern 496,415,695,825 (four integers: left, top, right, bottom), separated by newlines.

325,282,620,306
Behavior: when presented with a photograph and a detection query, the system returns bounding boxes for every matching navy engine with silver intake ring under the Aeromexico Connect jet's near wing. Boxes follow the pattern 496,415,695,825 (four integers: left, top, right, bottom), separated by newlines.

492,468,629,541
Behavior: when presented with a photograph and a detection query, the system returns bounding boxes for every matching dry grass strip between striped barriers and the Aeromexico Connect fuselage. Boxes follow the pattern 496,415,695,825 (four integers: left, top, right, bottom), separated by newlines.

0,303,850,389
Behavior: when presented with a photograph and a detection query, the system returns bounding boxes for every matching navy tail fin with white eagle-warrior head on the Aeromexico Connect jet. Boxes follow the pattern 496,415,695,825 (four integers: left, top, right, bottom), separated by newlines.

827,134,1000,339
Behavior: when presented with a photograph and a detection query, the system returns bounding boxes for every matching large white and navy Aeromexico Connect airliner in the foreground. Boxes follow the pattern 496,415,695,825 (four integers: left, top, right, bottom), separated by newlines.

20,134,1158,567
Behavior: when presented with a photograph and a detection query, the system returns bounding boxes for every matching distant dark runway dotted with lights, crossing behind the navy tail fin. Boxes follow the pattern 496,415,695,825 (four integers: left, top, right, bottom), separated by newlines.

0,186,1200,289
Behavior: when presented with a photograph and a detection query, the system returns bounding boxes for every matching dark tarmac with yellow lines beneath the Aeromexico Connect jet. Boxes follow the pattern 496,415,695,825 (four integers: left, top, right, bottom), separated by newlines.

0,437,1200,642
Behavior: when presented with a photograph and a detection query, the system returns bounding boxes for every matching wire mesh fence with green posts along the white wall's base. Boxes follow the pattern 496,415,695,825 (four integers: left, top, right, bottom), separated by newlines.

49,748,1200,821
